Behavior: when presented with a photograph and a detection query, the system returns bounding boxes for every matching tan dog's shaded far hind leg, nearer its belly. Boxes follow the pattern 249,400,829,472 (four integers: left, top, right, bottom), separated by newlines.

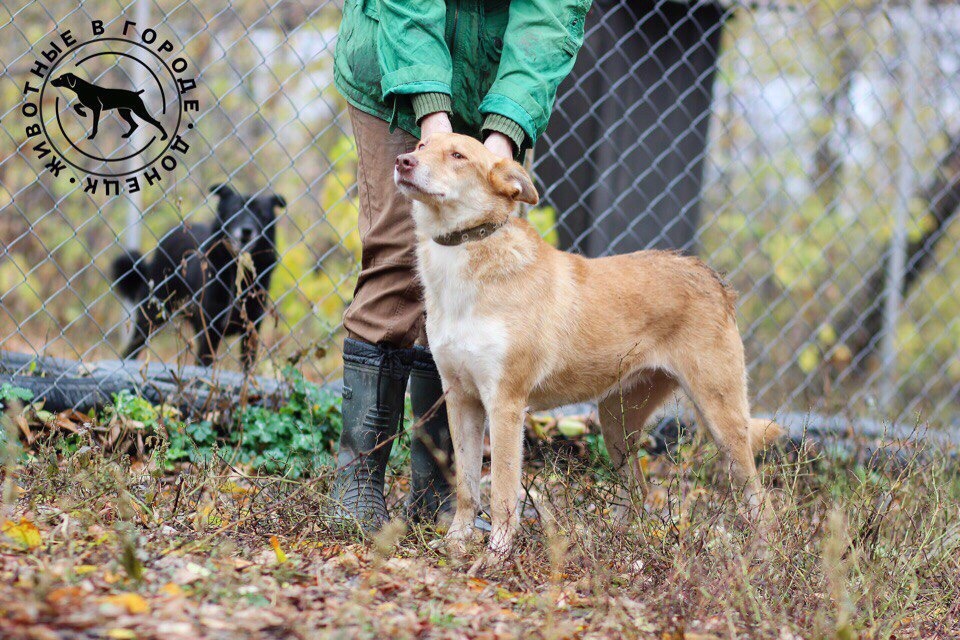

598,369,678,521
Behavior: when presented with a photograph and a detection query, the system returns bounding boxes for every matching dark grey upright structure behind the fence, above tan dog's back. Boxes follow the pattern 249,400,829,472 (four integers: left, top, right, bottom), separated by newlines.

536,0,730,256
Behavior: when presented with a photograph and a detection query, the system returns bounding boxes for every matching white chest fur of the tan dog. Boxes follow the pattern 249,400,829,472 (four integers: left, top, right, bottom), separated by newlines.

419,243,508,398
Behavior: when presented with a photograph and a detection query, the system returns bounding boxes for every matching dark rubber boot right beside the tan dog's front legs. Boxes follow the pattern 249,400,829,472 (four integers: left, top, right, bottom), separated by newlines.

408,346,454,522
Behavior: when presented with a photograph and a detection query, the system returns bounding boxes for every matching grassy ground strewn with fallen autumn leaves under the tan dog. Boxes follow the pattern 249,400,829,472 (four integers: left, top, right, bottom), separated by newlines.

0,398,960,640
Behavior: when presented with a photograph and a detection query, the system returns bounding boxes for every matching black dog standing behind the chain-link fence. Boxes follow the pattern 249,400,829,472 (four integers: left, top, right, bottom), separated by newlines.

112,185,286,369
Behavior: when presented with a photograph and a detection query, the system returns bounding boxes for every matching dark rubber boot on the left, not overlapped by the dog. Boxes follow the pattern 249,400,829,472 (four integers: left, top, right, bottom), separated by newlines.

331,338,413,533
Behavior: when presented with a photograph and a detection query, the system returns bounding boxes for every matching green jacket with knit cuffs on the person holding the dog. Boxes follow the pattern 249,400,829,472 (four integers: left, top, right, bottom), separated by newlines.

334,0,591,151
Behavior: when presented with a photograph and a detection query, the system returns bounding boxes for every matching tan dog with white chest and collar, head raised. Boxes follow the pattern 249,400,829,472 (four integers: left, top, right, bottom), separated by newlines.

394,134,781,568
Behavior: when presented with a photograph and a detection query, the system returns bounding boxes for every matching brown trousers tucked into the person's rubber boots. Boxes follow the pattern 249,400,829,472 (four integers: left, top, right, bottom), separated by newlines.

343,106,424,347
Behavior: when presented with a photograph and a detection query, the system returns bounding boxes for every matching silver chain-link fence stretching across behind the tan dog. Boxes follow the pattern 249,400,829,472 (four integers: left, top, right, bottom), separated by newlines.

0,0,960,430
